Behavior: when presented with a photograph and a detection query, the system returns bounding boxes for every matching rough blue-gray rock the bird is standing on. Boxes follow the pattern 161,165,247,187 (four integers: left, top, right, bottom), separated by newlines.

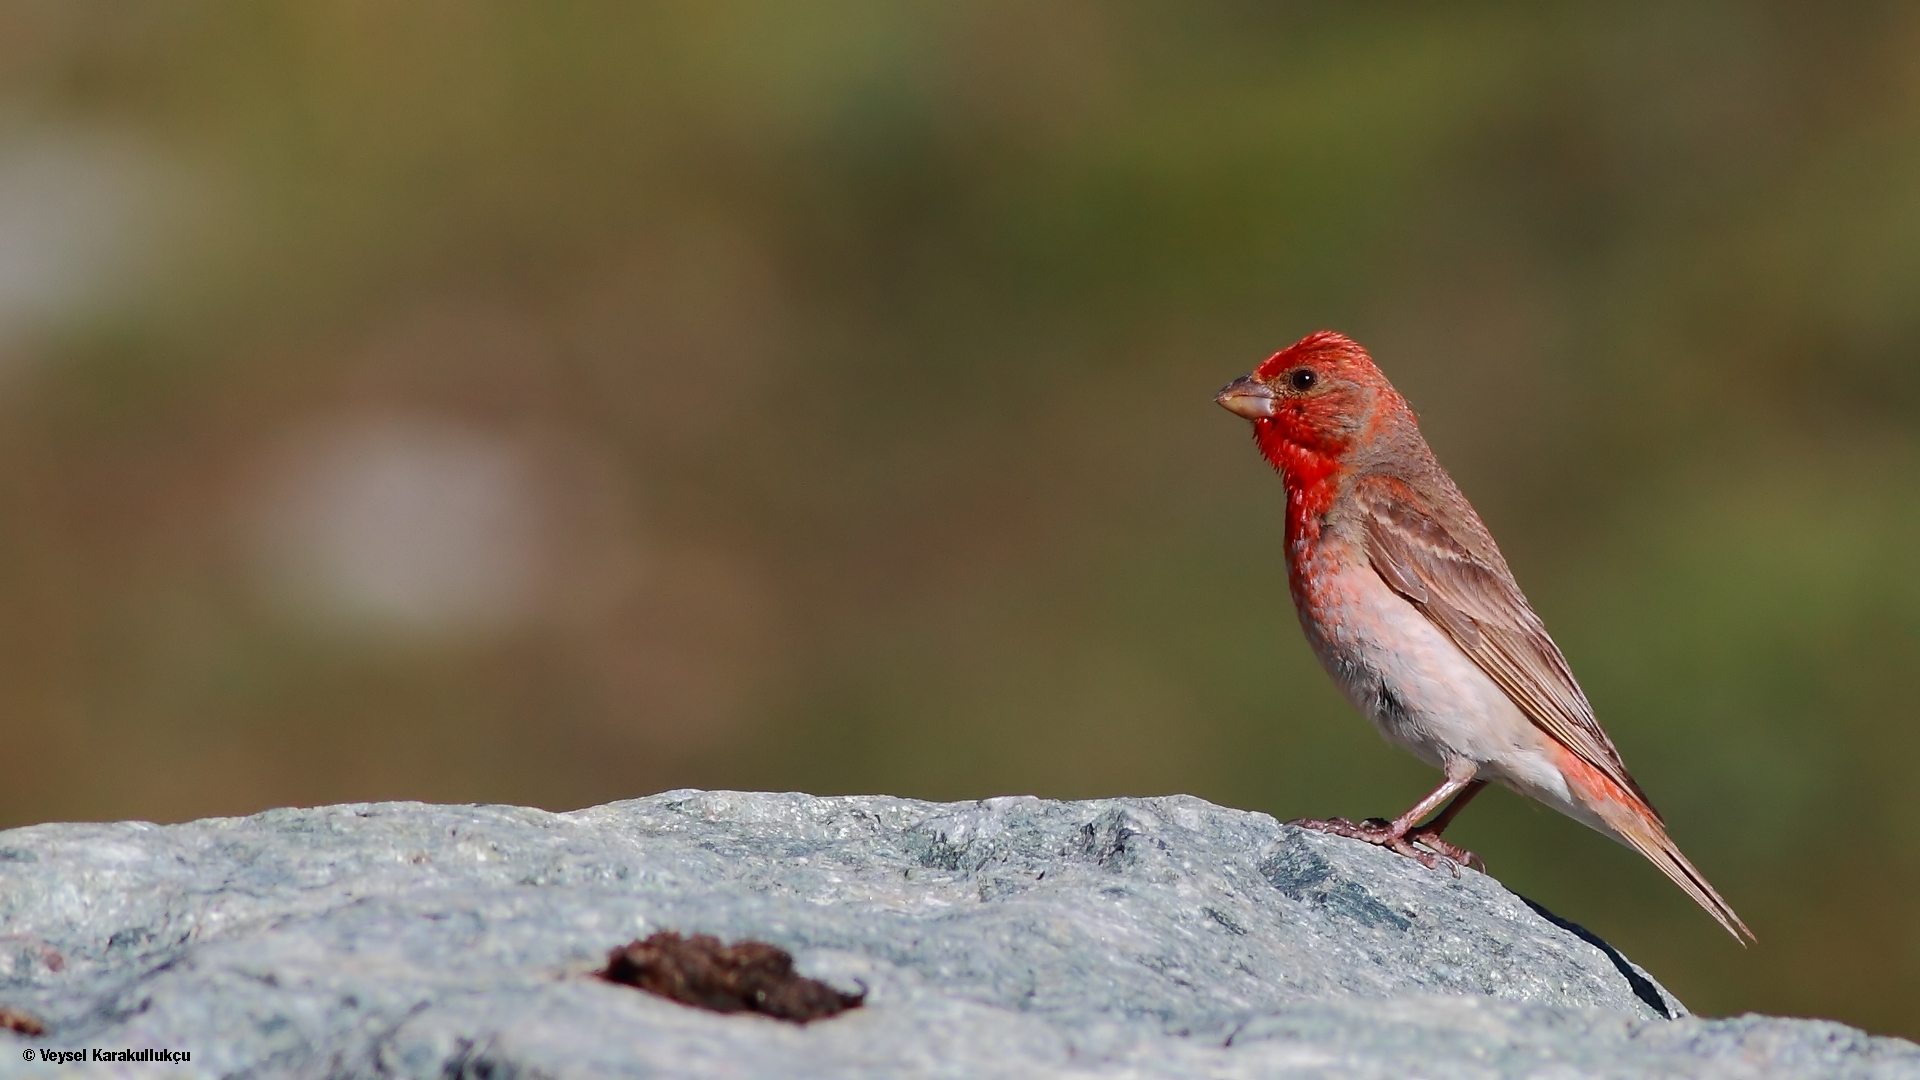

0,792,1920,1078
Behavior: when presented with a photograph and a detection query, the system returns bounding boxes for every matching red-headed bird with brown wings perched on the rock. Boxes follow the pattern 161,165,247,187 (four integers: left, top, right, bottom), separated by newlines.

1215,331,1757,944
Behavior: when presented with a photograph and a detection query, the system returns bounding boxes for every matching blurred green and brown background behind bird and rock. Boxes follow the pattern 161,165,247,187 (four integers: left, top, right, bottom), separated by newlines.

0,0,1920,1036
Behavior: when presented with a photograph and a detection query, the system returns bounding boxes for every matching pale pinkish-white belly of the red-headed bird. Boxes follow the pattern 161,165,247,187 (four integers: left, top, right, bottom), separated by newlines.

1300,563,1588,807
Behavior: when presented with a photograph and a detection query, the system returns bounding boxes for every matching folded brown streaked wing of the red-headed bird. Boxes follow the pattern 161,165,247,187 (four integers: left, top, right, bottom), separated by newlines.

1354,477,1659,821
